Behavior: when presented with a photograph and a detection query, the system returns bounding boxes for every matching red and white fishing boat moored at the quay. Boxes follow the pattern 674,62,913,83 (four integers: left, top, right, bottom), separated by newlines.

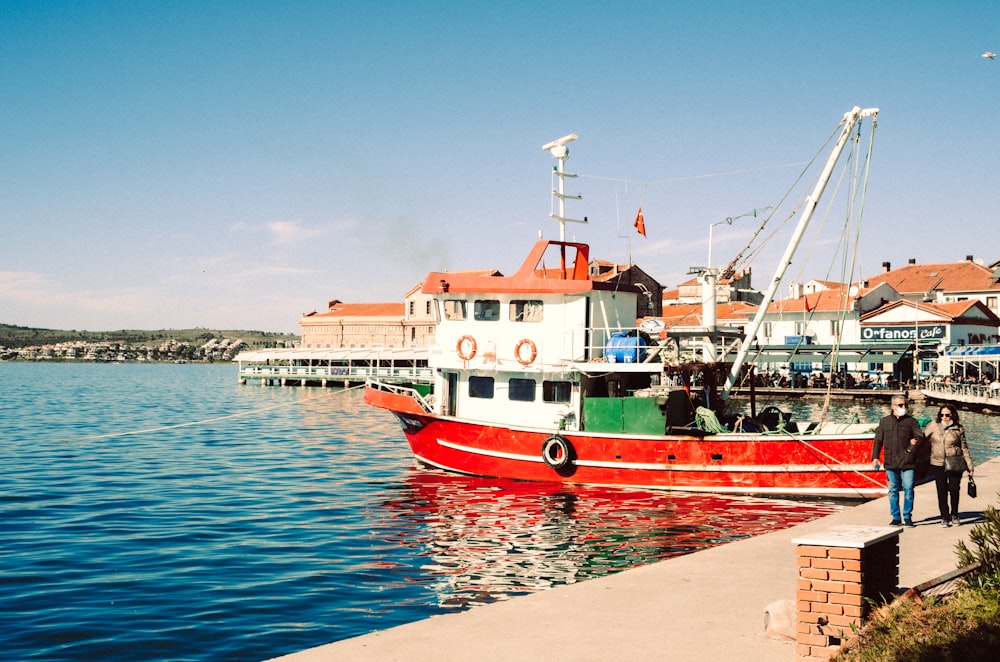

364,108,886,498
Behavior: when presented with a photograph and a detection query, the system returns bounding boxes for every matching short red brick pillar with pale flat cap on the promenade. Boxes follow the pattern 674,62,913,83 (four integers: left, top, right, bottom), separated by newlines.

792,526,900,660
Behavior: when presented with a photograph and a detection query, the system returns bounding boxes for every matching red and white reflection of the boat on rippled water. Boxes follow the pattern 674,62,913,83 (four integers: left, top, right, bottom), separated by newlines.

384,468,844,610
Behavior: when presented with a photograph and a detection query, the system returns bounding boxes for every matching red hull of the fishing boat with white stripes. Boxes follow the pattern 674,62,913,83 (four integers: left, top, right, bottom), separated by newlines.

365,388,886,498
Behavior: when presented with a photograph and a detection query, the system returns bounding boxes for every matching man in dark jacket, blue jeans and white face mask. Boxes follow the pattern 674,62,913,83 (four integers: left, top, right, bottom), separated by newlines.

872,395,925,526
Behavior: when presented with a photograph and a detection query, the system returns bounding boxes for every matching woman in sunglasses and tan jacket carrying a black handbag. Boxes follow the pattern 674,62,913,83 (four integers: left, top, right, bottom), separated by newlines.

926,405,972,526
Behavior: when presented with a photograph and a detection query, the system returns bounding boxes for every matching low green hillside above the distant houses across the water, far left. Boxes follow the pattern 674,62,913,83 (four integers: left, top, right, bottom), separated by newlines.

0,324,299,349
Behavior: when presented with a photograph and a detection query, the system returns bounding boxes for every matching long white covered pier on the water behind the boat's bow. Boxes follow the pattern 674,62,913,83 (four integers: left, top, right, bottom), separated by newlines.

239,347,433,387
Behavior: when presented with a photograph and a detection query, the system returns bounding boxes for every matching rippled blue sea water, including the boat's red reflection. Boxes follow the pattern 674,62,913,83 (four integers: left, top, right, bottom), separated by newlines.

0,363,1000,660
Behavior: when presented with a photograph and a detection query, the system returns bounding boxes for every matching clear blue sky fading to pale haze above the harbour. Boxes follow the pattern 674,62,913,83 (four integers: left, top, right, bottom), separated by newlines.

0,0,1000,333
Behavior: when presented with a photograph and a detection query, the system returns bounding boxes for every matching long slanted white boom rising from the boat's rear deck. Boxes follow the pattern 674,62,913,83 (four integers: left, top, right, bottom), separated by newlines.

722,106,879,400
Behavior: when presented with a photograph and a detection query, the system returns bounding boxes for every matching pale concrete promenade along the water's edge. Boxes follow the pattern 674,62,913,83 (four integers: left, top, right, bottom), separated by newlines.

270,458,1000,662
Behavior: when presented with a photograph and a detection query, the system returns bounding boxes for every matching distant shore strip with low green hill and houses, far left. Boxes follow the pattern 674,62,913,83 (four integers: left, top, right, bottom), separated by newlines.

0,324,299,363
